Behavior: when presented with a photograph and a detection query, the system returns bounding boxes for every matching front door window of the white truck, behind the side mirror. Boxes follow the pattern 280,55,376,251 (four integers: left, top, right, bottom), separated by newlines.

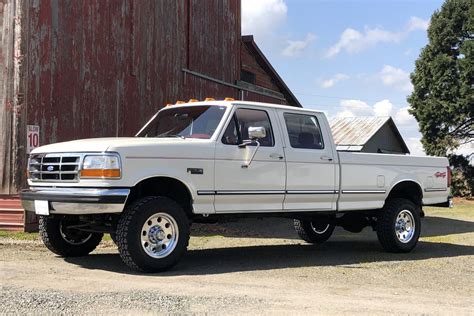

222,109,275,147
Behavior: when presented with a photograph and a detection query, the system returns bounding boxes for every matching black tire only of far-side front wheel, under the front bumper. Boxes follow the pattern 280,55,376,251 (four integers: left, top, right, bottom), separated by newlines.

39,216,103,257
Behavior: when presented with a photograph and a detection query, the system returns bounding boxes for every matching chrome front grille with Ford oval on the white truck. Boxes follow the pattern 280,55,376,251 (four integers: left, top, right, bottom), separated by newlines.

28,153,81,182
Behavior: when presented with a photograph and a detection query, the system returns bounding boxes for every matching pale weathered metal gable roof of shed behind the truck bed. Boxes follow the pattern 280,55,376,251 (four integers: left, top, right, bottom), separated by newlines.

329,116,410,153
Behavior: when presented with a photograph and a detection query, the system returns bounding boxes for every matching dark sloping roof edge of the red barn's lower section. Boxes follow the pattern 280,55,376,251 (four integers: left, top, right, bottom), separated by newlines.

242,35,302,108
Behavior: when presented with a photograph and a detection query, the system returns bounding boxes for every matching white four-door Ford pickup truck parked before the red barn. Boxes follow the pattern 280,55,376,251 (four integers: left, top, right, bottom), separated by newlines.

21,100,451,271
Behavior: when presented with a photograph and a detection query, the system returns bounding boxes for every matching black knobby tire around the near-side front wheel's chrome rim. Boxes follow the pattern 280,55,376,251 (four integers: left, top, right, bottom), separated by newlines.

116,196,190,272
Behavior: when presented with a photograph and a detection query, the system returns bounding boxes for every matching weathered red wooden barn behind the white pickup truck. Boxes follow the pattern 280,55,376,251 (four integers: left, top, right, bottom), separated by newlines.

0,0,301,229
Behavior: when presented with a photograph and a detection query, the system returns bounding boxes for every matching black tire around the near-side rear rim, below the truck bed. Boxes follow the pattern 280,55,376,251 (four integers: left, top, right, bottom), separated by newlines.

376,198,421,253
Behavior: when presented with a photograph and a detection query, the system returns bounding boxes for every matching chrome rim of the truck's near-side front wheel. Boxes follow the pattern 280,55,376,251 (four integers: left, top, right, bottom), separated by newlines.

140,213,179,259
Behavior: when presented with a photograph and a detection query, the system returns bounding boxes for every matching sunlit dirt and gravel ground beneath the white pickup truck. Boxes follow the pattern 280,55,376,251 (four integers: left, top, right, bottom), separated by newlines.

0,202,474,315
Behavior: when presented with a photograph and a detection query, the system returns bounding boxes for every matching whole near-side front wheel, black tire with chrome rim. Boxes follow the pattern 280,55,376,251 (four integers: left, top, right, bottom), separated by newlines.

116,196,190,272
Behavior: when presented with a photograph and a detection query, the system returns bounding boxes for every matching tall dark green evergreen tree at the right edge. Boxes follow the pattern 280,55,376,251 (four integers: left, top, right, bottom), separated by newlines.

408,0,474,156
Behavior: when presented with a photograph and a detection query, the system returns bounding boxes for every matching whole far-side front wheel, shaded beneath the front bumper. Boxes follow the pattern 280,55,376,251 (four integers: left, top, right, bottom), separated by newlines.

39,216,103,257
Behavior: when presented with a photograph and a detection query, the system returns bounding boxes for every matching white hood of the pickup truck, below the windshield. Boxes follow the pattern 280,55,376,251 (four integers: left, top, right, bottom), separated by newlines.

32,137,206,154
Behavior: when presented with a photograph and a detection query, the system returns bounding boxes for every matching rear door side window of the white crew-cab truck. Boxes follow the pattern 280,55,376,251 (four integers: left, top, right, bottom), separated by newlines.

284,113,324,149
